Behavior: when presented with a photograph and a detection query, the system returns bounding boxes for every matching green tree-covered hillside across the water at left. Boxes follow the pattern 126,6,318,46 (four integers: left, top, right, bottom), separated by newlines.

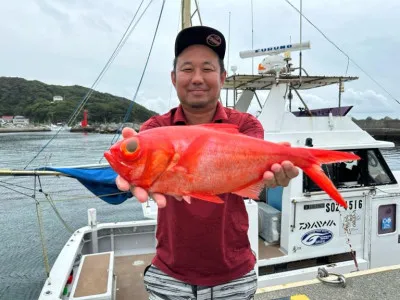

0,77,156,123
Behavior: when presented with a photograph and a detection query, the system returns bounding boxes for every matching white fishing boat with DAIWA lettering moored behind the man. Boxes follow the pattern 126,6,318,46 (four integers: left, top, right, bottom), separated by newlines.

3,1,400,300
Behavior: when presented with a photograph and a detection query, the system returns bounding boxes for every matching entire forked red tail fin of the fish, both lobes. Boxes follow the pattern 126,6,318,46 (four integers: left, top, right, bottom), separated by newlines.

298,148,360,208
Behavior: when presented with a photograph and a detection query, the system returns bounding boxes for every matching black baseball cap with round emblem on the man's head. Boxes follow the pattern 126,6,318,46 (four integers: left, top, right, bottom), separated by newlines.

175,26,226,59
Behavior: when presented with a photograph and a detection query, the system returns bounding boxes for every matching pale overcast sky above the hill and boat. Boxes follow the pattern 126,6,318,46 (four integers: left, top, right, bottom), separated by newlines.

0,0,400,119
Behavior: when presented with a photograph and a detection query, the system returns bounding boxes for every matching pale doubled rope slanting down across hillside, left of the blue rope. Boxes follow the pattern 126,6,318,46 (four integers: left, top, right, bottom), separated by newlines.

24,0,153,170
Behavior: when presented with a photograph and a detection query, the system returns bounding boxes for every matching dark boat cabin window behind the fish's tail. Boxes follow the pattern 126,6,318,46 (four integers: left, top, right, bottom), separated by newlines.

303,149,396,192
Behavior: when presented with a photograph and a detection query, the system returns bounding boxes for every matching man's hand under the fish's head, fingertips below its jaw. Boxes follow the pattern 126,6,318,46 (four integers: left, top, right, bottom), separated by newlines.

115,127,167,208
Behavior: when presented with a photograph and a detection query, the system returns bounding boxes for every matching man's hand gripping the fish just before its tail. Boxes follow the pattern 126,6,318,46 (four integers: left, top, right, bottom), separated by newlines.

264,142,299,188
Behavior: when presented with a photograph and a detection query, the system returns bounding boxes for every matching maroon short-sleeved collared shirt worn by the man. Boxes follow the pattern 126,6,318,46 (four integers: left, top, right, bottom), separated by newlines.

140,102,264,286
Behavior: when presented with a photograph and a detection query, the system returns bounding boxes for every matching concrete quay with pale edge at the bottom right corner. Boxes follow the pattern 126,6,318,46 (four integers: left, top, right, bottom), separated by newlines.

255,266,400,300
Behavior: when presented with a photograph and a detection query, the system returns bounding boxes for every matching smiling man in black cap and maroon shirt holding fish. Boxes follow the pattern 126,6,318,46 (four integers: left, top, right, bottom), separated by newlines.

117,26,298,300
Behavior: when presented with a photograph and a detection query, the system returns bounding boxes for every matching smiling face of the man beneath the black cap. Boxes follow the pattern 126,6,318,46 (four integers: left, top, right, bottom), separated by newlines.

171,45,226,110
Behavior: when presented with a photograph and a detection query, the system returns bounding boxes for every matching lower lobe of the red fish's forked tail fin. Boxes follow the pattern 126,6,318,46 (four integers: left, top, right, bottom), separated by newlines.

302,164,347,208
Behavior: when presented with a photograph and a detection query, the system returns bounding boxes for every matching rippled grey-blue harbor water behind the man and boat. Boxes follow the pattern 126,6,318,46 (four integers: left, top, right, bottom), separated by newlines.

0,131,400,300
